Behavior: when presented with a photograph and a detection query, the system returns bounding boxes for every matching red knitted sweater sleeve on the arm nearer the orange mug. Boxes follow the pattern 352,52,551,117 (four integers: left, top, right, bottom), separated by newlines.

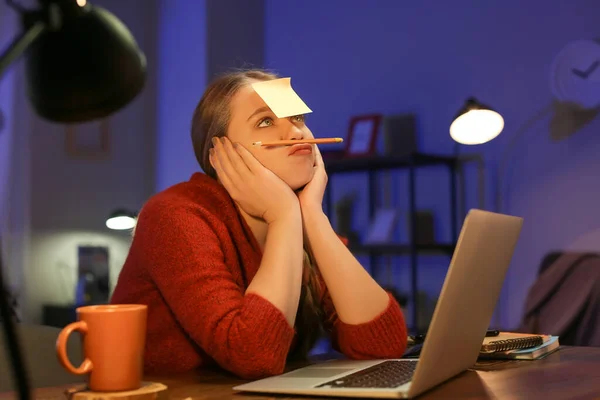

134,199,294,379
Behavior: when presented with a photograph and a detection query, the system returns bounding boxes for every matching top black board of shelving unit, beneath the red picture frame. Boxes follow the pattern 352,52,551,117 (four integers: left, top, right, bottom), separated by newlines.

324,153,457,174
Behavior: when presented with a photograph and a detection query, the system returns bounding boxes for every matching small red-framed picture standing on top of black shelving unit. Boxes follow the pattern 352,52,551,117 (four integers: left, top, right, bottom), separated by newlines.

344,114,383,157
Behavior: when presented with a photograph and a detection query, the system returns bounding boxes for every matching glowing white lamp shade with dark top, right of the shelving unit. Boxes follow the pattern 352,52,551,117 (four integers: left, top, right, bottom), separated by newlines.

450,97,504,145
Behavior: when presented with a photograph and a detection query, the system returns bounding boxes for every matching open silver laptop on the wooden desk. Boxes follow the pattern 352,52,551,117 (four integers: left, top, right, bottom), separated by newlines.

234,210,523,398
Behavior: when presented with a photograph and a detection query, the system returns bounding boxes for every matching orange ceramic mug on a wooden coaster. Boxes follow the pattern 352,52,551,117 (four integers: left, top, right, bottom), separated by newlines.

56,304,148,392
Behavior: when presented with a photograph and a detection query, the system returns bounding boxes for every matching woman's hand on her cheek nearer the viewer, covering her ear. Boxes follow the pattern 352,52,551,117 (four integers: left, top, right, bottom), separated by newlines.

210,138,300,224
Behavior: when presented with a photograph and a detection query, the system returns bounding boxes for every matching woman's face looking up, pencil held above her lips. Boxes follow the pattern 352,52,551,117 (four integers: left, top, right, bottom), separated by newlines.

227,84,315,190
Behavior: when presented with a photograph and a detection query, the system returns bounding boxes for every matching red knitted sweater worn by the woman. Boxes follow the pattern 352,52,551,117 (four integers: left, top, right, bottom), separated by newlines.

111,173,406,379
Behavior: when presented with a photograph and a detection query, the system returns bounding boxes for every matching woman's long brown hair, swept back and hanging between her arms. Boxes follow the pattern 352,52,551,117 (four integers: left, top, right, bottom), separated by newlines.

192,69,323,359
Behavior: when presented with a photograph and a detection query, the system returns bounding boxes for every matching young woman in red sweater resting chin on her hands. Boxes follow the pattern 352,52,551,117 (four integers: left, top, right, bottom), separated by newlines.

112,70,407,379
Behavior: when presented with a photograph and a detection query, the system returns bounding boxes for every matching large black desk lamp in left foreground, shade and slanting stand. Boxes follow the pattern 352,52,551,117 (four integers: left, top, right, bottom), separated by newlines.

0,0,146,399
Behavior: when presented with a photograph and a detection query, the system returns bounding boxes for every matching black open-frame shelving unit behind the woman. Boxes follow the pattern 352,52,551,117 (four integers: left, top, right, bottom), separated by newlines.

324,153,460,330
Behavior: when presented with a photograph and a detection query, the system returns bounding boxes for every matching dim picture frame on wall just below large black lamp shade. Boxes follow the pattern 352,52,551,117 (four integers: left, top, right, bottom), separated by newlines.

65,119,110,160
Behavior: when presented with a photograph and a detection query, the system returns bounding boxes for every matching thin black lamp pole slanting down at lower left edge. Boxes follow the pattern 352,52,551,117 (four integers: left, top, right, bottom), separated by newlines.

0,236,31,400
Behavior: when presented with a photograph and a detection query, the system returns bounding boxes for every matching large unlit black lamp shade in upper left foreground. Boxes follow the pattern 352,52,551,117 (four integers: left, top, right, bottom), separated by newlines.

24,0,146,123
